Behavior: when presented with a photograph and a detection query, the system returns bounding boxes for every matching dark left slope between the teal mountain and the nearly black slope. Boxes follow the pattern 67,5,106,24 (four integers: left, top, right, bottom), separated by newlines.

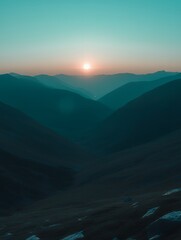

0,99,85,169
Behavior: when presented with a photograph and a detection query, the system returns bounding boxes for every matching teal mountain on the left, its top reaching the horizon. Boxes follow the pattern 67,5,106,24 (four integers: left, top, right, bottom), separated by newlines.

0,74,111,138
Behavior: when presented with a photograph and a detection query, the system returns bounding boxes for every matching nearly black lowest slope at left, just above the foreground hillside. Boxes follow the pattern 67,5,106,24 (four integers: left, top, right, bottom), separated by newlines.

0,149,75,212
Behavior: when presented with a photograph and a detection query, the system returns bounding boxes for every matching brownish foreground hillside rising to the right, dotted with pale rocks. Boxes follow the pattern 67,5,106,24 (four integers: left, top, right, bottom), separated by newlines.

0,129,181,240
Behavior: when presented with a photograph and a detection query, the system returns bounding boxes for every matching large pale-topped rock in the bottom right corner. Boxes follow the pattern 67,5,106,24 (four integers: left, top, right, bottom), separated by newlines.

148,211,181,239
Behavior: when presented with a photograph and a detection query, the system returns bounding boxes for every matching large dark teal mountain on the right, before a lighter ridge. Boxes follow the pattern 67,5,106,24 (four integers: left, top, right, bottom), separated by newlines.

92,79,181,153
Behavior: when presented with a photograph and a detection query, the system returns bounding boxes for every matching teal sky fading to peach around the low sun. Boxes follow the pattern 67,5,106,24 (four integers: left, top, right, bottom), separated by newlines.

0,0,181,75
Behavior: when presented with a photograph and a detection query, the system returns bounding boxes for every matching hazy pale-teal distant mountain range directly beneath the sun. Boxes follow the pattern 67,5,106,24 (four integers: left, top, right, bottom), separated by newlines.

10,71,179,100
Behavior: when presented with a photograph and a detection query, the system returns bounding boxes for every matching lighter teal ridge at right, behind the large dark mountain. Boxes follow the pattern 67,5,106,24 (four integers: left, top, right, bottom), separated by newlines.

99,74,181,110
